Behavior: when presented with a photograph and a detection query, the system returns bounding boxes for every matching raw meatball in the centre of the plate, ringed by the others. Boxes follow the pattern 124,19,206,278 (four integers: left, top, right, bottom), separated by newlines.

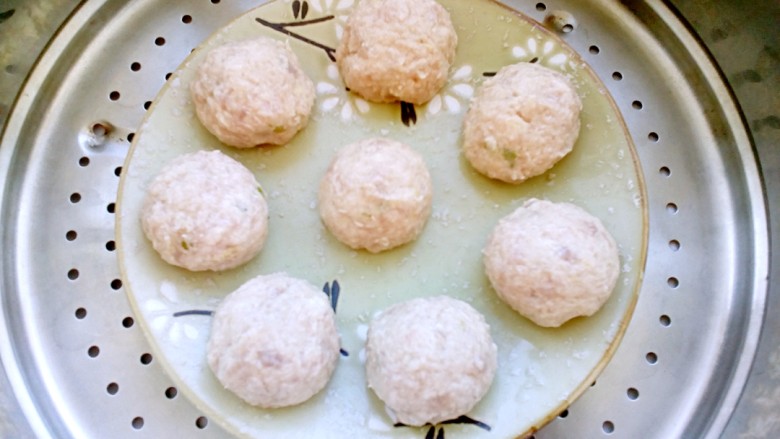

319,138,433,253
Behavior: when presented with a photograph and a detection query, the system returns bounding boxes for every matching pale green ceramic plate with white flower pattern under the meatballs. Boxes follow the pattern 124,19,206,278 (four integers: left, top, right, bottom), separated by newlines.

117,0,647,438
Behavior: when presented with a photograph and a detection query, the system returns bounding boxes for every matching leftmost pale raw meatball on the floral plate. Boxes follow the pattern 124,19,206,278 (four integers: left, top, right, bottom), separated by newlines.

141,151,268,271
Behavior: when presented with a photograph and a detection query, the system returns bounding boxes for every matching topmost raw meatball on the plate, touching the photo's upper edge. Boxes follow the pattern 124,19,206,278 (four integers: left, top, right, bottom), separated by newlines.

336,0,458,104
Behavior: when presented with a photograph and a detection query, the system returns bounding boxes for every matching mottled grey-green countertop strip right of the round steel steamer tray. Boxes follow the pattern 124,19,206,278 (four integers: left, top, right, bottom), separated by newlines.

678,0,780,438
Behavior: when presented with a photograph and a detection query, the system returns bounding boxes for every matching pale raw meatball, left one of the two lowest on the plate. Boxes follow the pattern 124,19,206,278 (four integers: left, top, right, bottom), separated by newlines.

206,273,339,408
